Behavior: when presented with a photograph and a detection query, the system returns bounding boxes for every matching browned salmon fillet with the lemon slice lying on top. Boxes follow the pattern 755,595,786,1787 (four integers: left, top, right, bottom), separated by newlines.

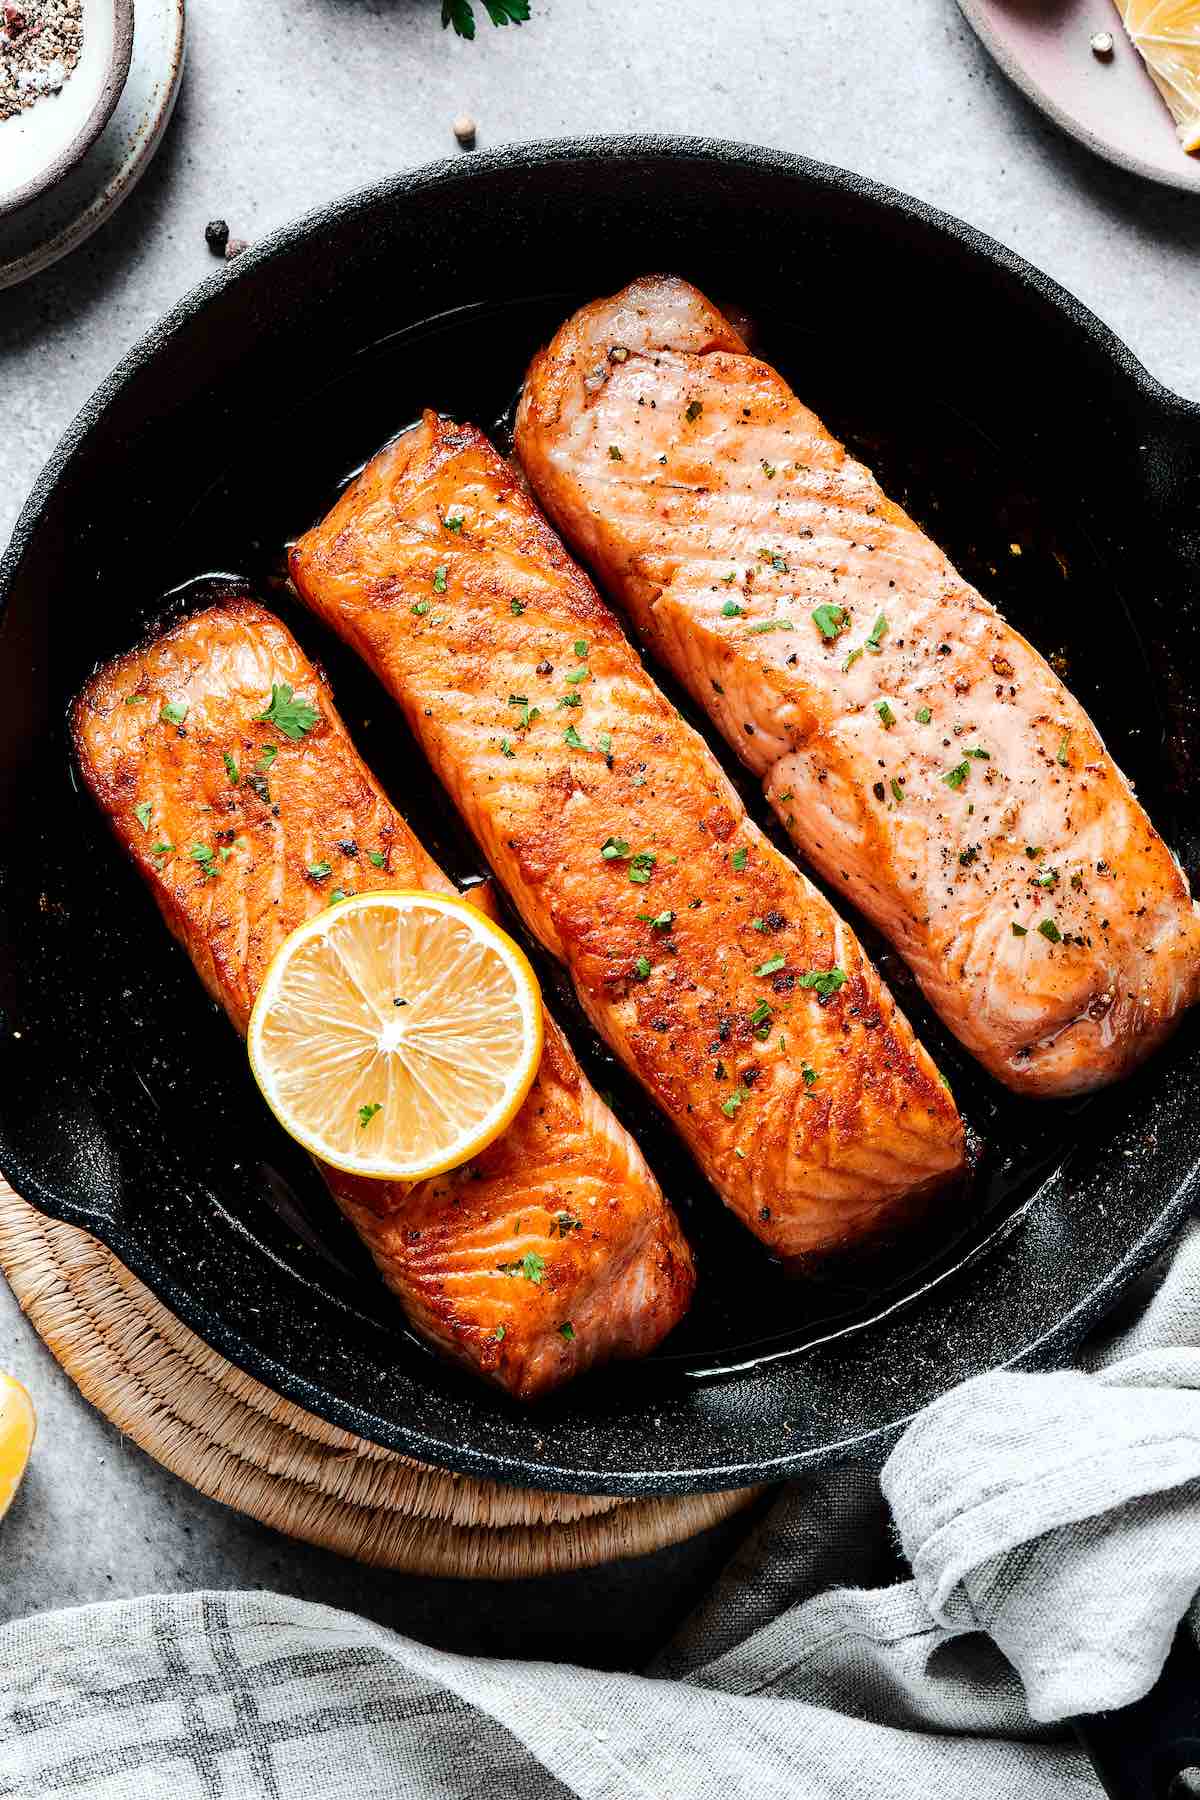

72,599,694,1399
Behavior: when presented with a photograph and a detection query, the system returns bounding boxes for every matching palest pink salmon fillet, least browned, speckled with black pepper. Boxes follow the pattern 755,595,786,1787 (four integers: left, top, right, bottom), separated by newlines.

516,275,1200,1094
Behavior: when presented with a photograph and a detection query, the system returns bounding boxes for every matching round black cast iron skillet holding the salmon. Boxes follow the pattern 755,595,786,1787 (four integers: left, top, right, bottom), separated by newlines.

0,139,1200,1494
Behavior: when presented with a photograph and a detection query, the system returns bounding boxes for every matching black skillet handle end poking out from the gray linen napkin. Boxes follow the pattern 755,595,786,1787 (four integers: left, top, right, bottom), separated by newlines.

1072,1620,1200,1800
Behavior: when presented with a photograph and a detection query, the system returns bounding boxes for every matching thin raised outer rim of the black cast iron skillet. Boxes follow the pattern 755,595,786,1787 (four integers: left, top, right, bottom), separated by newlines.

0,135,1200,1494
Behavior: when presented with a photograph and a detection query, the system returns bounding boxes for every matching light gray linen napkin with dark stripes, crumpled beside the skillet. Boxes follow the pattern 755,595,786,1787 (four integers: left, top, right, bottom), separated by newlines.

0,1224,1200,1800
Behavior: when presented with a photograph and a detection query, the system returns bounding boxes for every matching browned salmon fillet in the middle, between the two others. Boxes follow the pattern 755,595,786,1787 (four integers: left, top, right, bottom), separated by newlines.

291,414,963,1256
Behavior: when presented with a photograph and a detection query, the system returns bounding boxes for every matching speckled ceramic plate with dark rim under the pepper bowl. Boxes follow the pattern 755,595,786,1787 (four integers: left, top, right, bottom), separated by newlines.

0,0,185,288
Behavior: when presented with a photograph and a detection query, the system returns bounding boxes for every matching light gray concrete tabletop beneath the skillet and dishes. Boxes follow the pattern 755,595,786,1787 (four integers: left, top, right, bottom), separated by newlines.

0,0,1200,1665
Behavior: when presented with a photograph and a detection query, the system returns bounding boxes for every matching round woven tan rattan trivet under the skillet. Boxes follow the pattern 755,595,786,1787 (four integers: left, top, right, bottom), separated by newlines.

0,1181,757,1580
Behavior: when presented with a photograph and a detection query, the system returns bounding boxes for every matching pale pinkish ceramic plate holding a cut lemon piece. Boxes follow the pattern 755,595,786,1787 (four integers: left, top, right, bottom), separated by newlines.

959,0,1200,194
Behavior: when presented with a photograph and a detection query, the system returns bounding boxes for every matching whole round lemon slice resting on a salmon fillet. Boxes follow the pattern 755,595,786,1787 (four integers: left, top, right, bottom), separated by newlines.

248,893,542,1181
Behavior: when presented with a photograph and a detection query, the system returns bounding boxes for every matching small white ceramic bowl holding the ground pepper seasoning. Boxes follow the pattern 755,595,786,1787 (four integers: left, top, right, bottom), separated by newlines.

0,0,133,218
